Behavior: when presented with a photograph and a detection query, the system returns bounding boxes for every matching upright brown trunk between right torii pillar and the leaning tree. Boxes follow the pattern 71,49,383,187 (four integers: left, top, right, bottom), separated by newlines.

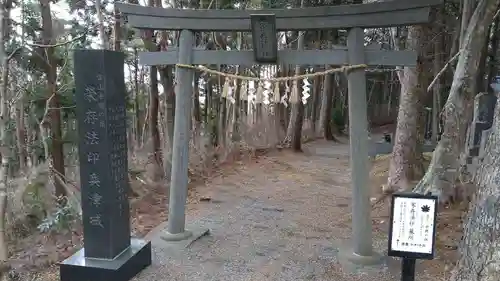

383,26,429,192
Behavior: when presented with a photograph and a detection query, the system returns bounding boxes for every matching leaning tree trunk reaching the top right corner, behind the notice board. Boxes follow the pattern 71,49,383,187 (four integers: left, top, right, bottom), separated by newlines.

414,0,500,202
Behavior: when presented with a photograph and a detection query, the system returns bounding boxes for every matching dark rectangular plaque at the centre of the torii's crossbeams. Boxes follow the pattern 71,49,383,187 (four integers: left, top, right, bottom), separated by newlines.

250,14,278,64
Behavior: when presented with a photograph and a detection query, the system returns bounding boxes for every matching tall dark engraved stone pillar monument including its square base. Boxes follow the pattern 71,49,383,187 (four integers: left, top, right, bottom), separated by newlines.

60,50,151,281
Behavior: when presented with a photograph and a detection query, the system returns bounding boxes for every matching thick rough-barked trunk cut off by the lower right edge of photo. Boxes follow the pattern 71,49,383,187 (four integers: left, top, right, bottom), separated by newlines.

451,93,500,281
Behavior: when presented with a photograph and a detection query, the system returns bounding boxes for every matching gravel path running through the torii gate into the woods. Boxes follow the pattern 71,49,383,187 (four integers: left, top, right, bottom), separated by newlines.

135,141,442,281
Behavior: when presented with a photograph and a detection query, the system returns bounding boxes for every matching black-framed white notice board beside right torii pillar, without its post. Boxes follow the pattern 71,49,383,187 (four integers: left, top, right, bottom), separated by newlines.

388,193,438,259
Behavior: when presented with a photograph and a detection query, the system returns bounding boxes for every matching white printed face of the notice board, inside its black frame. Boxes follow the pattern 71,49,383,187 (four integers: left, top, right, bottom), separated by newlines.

391,197,436,254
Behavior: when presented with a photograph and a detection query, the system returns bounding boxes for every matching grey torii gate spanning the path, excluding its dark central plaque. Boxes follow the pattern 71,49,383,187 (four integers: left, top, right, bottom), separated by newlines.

116,0,442,264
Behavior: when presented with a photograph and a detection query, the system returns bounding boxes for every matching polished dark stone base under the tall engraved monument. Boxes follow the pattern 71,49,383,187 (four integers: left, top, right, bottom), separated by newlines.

59,238,151,281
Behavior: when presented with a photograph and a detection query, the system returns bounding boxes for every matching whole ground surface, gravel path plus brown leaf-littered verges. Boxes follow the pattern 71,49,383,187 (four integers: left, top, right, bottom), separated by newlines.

12,135,466,281
